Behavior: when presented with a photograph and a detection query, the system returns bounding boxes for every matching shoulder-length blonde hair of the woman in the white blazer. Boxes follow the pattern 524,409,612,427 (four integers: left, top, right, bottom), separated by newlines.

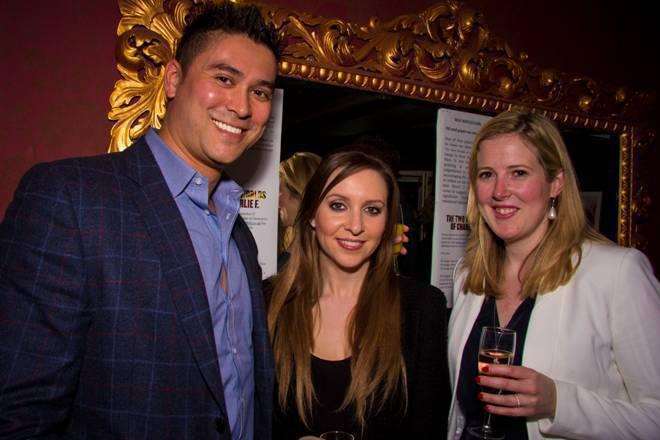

462,110,609,297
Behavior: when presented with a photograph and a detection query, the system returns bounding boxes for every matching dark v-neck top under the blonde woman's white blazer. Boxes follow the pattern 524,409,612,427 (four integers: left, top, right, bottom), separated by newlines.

456,296,534,440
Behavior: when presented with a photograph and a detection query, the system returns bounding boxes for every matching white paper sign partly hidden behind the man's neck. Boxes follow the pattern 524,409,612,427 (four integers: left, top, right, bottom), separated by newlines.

227,89,284,278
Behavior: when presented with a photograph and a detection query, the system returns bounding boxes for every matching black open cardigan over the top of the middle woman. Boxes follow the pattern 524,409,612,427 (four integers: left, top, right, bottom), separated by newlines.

264,277,451,440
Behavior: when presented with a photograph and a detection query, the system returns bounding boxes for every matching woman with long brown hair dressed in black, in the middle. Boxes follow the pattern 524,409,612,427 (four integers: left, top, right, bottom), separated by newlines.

268,150,449,439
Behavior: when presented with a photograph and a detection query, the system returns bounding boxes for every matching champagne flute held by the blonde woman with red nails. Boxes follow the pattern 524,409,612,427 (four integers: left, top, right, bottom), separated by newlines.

468,327,516,440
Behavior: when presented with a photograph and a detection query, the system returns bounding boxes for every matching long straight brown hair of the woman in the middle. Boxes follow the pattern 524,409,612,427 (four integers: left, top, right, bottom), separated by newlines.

268,151,406,427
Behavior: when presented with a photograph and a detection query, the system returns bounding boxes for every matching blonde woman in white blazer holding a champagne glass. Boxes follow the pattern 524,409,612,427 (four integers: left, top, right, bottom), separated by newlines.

448,112,660,439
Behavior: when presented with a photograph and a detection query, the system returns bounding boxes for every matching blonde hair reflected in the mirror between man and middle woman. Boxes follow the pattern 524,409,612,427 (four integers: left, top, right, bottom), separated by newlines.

279,151,321,252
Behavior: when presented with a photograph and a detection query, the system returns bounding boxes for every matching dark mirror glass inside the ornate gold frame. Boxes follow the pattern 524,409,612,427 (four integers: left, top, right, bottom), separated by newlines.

278,78,619,279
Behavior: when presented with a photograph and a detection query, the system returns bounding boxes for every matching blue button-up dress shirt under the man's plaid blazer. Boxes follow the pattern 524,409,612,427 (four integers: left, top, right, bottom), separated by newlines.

146,129,254,440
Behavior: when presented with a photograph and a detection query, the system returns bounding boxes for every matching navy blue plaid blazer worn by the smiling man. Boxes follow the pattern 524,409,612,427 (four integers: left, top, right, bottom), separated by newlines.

0,139,273,440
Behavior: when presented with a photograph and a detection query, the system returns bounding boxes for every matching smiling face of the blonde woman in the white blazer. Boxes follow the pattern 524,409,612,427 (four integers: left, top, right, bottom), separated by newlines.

475,133,564,252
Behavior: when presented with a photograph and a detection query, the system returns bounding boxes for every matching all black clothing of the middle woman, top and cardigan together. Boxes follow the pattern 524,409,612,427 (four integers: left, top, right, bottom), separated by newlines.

264,277,451,440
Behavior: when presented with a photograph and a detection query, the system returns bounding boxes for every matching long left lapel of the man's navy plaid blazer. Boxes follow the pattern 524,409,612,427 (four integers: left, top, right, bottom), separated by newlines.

120,138,226,413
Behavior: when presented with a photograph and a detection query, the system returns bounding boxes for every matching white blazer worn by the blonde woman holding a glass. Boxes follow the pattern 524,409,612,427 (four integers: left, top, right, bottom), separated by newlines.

448,243,660,440
